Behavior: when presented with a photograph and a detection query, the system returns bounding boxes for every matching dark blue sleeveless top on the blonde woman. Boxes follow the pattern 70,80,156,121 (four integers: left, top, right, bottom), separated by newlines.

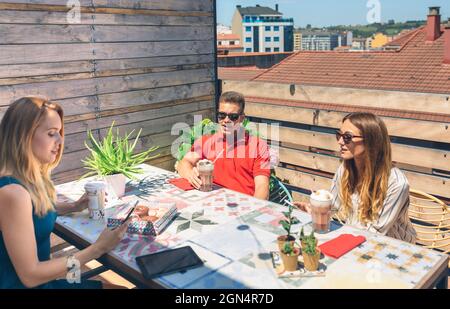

0,176,101,289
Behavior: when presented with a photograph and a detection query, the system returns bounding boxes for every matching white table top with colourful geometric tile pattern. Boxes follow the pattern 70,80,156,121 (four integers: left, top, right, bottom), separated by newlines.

57,165,444,288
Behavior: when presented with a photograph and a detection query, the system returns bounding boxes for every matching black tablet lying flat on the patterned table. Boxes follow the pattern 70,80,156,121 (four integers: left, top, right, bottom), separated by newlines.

136,246,203,279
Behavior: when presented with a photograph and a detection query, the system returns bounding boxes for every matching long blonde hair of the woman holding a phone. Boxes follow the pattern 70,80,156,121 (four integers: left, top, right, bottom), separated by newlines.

0,97,64,216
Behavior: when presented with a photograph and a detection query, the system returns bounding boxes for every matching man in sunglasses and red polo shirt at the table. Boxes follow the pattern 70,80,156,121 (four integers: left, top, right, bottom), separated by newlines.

178,91,270,199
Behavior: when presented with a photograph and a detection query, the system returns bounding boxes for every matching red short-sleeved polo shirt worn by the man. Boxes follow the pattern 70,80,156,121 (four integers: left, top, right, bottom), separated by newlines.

191,133,270,195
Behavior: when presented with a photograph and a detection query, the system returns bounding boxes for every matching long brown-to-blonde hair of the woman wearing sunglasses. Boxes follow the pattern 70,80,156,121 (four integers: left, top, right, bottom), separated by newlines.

338,113,392,224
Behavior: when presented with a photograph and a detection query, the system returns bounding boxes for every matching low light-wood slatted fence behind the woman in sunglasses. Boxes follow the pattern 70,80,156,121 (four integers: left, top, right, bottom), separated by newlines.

222,81,450,202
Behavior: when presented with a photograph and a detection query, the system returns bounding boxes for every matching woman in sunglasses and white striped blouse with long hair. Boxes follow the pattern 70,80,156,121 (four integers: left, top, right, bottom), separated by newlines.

294,113,416,243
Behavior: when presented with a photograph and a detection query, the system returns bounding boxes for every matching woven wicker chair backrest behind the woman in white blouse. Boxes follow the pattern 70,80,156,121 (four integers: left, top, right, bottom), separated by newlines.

409,189,450,253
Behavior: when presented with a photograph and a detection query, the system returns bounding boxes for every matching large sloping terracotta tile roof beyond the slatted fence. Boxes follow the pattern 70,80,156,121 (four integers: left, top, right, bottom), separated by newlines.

253,27,450,94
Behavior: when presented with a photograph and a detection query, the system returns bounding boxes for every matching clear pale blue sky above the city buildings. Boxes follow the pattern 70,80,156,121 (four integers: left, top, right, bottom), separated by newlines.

216,0,450,27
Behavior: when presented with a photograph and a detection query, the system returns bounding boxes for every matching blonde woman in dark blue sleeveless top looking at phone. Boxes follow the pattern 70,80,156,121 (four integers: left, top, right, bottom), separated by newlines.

0,97,132,288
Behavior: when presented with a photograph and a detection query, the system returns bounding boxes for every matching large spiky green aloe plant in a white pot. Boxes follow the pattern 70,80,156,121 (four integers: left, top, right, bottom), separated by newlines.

82,122,158,197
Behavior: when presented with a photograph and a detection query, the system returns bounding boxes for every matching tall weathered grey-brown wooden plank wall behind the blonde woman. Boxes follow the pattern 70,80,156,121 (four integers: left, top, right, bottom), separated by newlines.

0,0,216,183
